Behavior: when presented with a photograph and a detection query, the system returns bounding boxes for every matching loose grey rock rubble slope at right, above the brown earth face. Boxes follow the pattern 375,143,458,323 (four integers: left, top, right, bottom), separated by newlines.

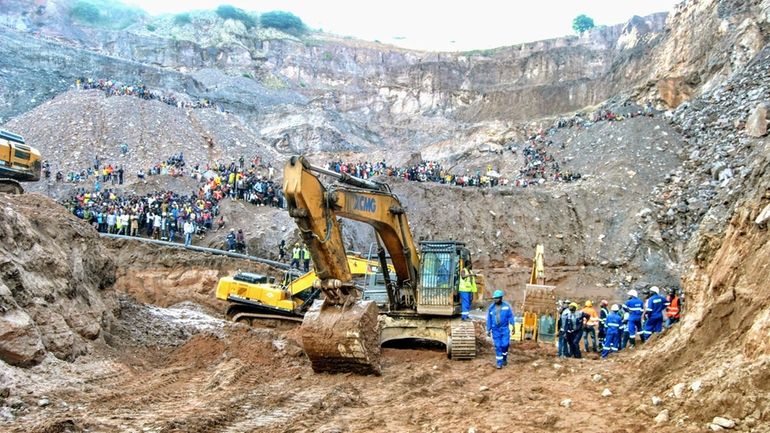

653,47,770,246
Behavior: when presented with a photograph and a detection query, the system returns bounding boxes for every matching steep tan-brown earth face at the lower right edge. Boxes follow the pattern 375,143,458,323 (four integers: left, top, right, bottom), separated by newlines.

645,142,770,426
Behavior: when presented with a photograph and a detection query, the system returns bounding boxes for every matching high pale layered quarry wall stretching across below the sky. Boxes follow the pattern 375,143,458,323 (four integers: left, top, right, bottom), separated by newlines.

0,0,770,157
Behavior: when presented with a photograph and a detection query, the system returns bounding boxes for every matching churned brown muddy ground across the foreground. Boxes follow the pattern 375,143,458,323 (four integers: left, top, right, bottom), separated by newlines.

6,318,674,433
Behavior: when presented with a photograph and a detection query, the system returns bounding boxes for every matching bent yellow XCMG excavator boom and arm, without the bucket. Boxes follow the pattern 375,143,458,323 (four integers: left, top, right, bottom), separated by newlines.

284,156,420,308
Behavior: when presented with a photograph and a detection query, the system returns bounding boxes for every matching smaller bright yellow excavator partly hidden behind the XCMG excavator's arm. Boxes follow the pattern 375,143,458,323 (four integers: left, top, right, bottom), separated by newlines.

216,255,393,325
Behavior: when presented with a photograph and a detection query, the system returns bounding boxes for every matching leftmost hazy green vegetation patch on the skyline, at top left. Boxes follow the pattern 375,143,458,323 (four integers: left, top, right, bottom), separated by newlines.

70,0,145,30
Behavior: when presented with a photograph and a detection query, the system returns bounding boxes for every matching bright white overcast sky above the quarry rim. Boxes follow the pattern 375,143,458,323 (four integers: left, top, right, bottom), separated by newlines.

126,0,681,51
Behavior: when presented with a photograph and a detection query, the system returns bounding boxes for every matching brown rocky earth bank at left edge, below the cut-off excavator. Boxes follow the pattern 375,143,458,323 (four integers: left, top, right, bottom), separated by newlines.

0,194,115,366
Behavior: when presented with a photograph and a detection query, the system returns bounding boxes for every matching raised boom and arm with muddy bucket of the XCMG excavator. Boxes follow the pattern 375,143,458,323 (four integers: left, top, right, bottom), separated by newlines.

283,156,420,374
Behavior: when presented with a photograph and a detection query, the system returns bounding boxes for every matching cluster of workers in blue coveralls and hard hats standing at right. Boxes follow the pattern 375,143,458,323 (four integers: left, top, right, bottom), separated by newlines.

558,286,683,358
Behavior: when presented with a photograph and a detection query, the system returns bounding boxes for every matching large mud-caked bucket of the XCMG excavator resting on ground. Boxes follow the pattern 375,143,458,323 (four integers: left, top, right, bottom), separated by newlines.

299,300,381,376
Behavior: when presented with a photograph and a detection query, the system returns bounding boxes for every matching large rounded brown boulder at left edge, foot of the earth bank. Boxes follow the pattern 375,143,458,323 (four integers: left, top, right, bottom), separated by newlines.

0,309,45,367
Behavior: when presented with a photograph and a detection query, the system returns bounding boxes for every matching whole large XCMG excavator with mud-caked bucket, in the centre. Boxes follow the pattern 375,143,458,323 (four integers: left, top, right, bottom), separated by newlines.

283,156,476,374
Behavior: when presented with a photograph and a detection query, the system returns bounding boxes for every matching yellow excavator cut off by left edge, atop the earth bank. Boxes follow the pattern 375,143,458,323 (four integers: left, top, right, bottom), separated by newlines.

0,129,42,194
